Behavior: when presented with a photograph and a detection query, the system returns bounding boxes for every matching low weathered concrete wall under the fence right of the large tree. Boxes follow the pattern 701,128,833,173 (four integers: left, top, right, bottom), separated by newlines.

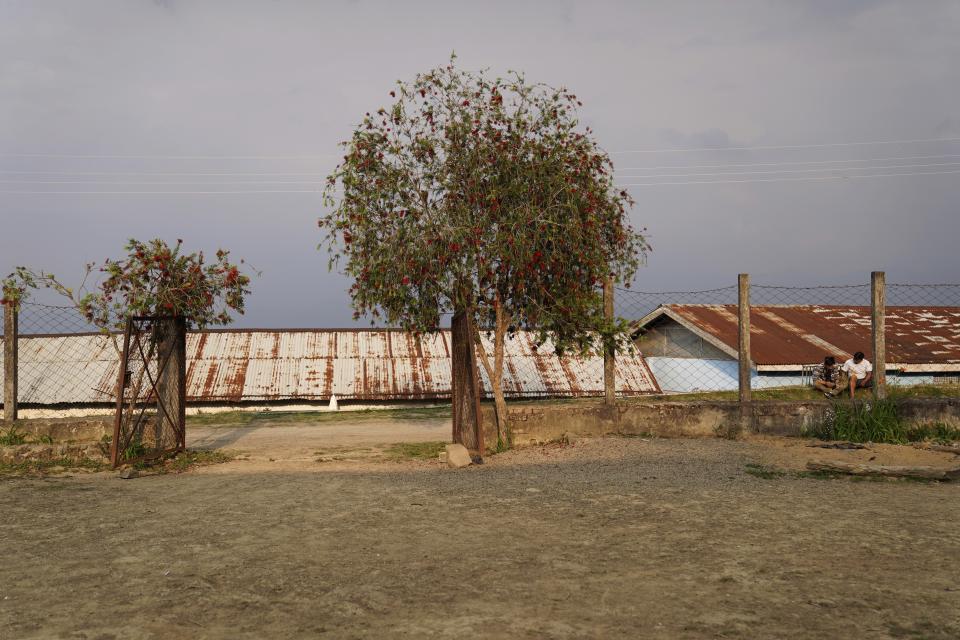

481,398,960,449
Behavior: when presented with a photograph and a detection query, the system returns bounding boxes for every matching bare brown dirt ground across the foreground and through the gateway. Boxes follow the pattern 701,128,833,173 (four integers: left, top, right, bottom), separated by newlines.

0,420,960,639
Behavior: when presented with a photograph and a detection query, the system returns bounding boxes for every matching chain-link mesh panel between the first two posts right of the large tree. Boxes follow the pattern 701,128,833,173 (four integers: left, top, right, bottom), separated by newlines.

616,286,738,393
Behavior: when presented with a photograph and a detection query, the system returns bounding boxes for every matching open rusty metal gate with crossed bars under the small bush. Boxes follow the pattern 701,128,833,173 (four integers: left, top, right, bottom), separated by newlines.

110,317,186,467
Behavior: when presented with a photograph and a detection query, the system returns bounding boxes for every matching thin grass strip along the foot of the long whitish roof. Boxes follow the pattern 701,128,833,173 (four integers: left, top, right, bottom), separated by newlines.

187,406,451,427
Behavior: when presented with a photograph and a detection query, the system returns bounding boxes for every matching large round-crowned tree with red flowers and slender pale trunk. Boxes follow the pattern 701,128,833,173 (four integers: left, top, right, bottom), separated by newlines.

319,57,647,440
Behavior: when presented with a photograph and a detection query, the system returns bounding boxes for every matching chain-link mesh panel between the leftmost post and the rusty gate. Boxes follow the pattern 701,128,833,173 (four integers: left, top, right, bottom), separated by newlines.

17,303,122,418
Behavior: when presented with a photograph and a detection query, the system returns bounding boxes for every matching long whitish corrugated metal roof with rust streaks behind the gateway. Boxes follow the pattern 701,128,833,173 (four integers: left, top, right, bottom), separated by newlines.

5,329,659,404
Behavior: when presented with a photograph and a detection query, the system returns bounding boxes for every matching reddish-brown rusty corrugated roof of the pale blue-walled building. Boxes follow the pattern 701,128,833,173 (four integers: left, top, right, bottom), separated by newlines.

637,304,960,371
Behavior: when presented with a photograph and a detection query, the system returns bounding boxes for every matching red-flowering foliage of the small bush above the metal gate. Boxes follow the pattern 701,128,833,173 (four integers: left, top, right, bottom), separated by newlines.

3,239,250,331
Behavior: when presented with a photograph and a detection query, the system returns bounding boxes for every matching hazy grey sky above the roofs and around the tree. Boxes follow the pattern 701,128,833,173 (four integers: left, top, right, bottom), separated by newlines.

0,0,960,328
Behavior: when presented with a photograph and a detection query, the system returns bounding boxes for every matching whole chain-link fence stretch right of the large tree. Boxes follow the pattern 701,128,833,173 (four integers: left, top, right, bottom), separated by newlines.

617,279,960,395
